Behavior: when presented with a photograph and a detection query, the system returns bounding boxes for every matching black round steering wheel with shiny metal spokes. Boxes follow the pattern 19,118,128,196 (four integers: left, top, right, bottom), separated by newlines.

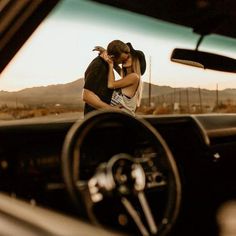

62,111,181,236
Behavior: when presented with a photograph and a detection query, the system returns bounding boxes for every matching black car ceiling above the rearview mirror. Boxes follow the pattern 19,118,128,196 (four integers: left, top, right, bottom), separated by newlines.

93,0,236,38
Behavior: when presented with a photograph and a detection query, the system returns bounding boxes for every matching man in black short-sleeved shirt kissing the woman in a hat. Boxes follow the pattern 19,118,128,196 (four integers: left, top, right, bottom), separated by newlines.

82,40,130,115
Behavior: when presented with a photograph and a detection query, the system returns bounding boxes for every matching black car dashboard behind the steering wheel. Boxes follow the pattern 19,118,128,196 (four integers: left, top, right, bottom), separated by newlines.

0,114,236,235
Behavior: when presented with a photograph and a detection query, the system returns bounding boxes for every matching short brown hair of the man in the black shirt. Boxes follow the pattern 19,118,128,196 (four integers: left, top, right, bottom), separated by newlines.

107,40,130,58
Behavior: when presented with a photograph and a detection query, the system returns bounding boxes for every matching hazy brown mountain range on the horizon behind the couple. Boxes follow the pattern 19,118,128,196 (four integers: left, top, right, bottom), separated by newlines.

0,79,236,107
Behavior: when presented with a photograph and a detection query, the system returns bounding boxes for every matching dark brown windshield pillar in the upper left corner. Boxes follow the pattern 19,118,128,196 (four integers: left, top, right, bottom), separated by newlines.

0,0,59,73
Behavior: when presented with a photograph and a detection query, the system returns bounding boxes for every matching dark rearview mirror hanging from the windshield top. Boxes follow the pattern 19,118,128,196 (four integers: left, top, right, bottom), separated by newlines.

171,48,236,73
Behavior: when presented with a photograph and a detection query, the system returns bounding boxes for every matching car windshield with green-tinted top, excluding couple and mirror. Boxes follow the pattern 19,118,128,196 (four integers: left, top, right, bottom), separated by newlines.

0,0,236,120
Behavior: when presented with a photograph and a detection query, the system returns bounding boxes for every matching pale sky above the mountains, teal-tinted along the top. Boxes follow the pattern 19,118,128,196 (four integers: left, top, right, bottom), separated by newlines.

0,0,236,91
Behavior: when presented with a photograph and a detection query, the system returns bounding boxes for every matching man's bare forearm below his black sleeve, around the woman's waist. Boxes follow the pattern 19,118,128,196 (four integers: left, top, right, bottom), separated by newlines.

82,89,114,109
